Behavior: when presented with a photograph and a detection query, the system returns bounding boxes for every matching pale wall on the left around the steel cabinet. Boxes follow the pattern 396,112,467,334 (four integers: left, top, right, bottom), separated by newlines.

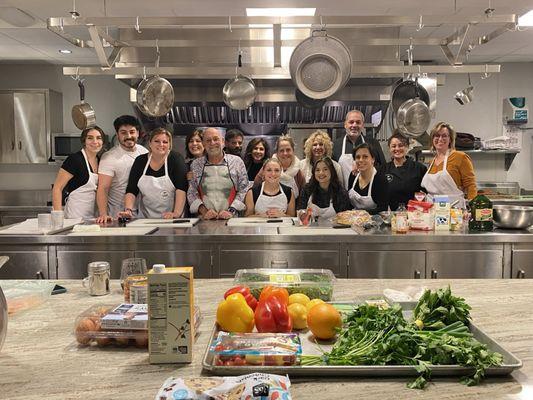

0,64,133,190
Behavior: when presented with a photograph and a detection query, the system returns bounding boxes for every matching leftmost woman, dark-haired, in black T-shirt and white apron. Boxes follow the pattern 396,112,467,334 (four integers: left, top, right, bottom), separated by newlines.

52,126,105,220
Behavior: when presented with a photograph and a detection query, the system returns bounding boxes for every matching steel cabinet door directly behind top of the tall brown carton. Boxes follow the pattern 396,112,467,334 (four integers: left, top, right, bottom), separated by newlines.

135,250,212,278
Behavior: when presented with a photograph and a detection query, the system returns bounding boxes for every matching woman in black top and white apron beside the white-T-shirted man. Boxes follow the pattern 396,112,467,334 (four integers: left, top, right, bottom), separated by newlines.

122,128,186,219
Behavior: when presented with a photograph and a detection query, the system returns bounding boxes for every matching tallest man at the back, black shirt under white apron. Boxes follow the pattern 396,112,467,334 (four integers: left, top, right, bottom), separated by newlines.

333,110,386,187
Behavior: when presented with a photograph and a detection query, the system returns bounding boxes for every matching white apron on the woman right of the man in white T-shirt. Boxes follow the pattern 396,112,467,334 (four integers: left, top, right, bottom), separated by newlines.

137,156,176,218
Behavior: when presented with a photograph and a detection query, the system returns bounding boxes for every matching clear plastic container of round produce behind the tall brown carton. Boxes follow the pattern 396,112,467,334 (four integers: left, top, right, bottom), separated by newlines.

74,304,202,348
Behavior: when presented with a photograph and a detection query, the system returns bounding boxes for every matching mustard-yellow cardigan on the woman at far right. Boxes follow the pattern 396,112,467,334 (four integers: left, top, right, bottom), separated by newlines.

428,150,477,200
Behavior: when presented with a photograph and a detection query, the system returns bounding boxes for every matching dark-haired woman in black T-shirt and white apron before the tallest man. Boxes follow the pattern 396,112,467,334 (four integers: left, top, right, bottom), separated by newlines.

348,143,388,214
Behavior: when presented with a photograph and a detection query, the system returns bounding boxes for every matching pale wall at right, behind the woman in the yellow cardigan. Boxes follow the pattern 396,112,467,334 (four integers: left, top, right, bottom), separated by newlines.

432,63,533,190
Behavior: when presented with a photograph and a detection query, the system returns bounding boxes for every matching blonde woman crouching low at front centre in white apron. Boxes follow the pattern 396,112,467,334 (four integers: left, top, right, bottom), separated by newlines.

245,158,296,218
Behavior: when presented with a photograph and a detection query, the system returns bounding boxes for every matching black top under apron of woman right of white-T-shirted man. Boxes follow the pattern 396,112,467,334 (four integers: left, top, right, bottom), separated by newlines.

126,151,188,196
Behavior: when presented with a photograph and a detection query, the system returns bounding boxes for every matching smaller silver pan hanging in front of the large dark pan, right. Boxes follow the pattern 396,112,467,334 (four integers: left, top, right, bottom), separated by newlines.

396,78,431,138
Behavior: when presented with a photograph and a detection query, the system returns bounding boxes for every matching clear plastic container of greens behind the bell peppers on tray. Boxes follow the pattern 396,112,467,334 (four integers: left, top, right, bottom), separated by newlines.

234,268,335,301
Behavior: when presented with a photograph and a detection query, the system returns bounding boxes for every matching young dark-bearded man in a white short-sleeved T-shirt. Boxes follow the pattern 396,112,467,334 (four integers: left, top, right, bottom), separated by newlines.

96,115,147,223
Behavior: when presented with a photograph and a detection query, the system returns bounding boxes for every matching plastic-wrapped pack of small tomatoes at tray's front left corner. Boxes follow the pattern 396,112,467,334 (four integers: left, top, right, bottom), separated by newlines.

211,332,302,366
